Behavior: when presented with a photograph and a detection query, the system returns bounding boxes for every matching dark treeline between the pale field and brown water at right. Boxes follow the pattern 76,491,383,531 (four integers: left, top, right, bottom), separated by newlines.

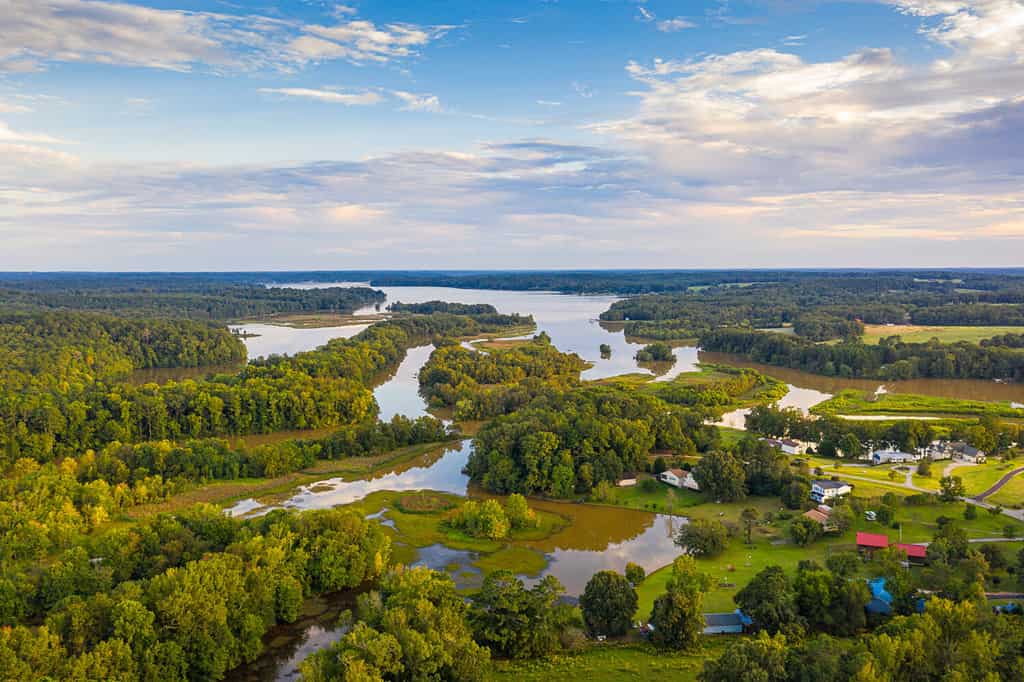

700,330,1024,381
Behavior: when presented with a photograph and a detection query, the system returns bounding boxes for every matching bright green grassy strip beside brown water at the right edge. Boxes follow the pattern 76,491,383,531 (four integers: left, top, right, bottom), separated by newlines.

811,390,1024,419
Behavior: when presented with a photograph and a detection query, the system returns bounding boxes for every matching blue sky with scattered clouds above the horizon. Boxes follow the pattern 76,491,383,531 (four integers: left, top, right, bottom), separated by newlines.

0,0,1024,270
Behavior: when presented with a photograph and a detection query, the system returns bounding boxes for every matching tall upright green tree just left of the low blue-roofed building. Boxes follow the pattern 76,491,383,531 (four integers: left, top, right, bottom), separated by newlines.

650,554,712,649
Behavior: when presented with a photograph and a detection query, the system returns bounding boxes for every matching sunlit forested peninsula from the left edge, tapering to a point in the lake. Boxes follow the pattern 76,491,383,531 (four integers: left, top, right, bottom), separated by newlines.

0,314,523,463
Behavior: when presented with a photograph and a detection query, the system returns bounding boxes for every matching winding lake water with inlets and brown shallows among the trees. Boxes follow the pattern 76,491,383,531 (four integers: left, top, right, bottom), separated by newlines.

211,283,1024,681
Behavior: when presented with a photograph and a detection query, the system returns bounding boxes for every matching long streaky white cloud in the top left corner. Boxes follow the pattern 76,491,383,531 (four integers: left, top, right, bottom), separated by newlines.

0,0,453,72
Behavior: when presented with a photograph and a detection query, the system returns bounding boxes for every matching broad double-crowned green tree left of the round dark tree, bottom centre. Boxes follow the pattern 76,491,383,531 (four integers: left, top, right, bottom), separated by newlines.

469,569,571,658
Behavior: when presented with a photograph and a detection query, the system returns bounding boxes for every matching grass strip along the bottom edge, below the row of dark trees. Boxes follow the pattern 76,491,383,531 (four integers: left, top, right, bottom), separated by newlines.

486,636,732,682
